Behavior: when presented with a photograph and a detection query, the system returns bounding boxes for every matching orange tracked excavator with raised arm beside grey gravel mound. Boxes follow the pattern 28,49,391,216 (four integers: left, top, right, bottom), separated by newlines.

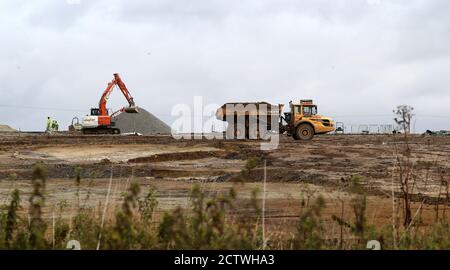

81,73,138,134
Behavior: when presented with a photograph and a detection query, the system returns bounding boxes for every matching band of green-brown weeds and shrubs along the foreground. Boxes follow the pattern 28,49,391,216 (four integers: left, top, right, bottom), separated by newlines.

0,164,450,249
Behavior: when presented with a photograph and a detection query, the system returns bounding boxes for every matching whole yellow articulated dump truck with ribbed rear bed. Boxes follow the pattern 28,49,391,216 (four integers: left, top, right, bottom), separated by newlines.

216,100,335,140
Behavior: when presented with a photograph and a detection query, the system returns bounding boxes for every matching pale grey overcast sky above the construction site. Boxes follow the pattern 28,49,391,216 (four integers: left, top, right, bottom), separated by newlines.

0,0,450,131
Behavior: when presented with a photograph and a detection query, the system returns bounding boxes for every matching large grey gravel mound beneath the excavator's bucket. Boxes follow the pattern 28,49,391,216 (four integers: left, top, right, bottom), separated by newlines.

113,108,171,135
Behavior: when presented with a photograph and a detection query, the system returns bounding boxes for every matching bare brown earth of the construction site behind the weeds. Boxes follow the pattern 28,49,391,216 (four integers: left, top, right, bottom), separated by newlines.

0,133,450,237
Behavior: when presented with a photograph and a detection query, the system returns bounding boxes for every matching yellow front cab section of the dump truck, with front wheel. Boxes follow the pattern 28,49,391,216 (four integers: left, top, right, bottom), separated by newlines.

283,100,334,140
